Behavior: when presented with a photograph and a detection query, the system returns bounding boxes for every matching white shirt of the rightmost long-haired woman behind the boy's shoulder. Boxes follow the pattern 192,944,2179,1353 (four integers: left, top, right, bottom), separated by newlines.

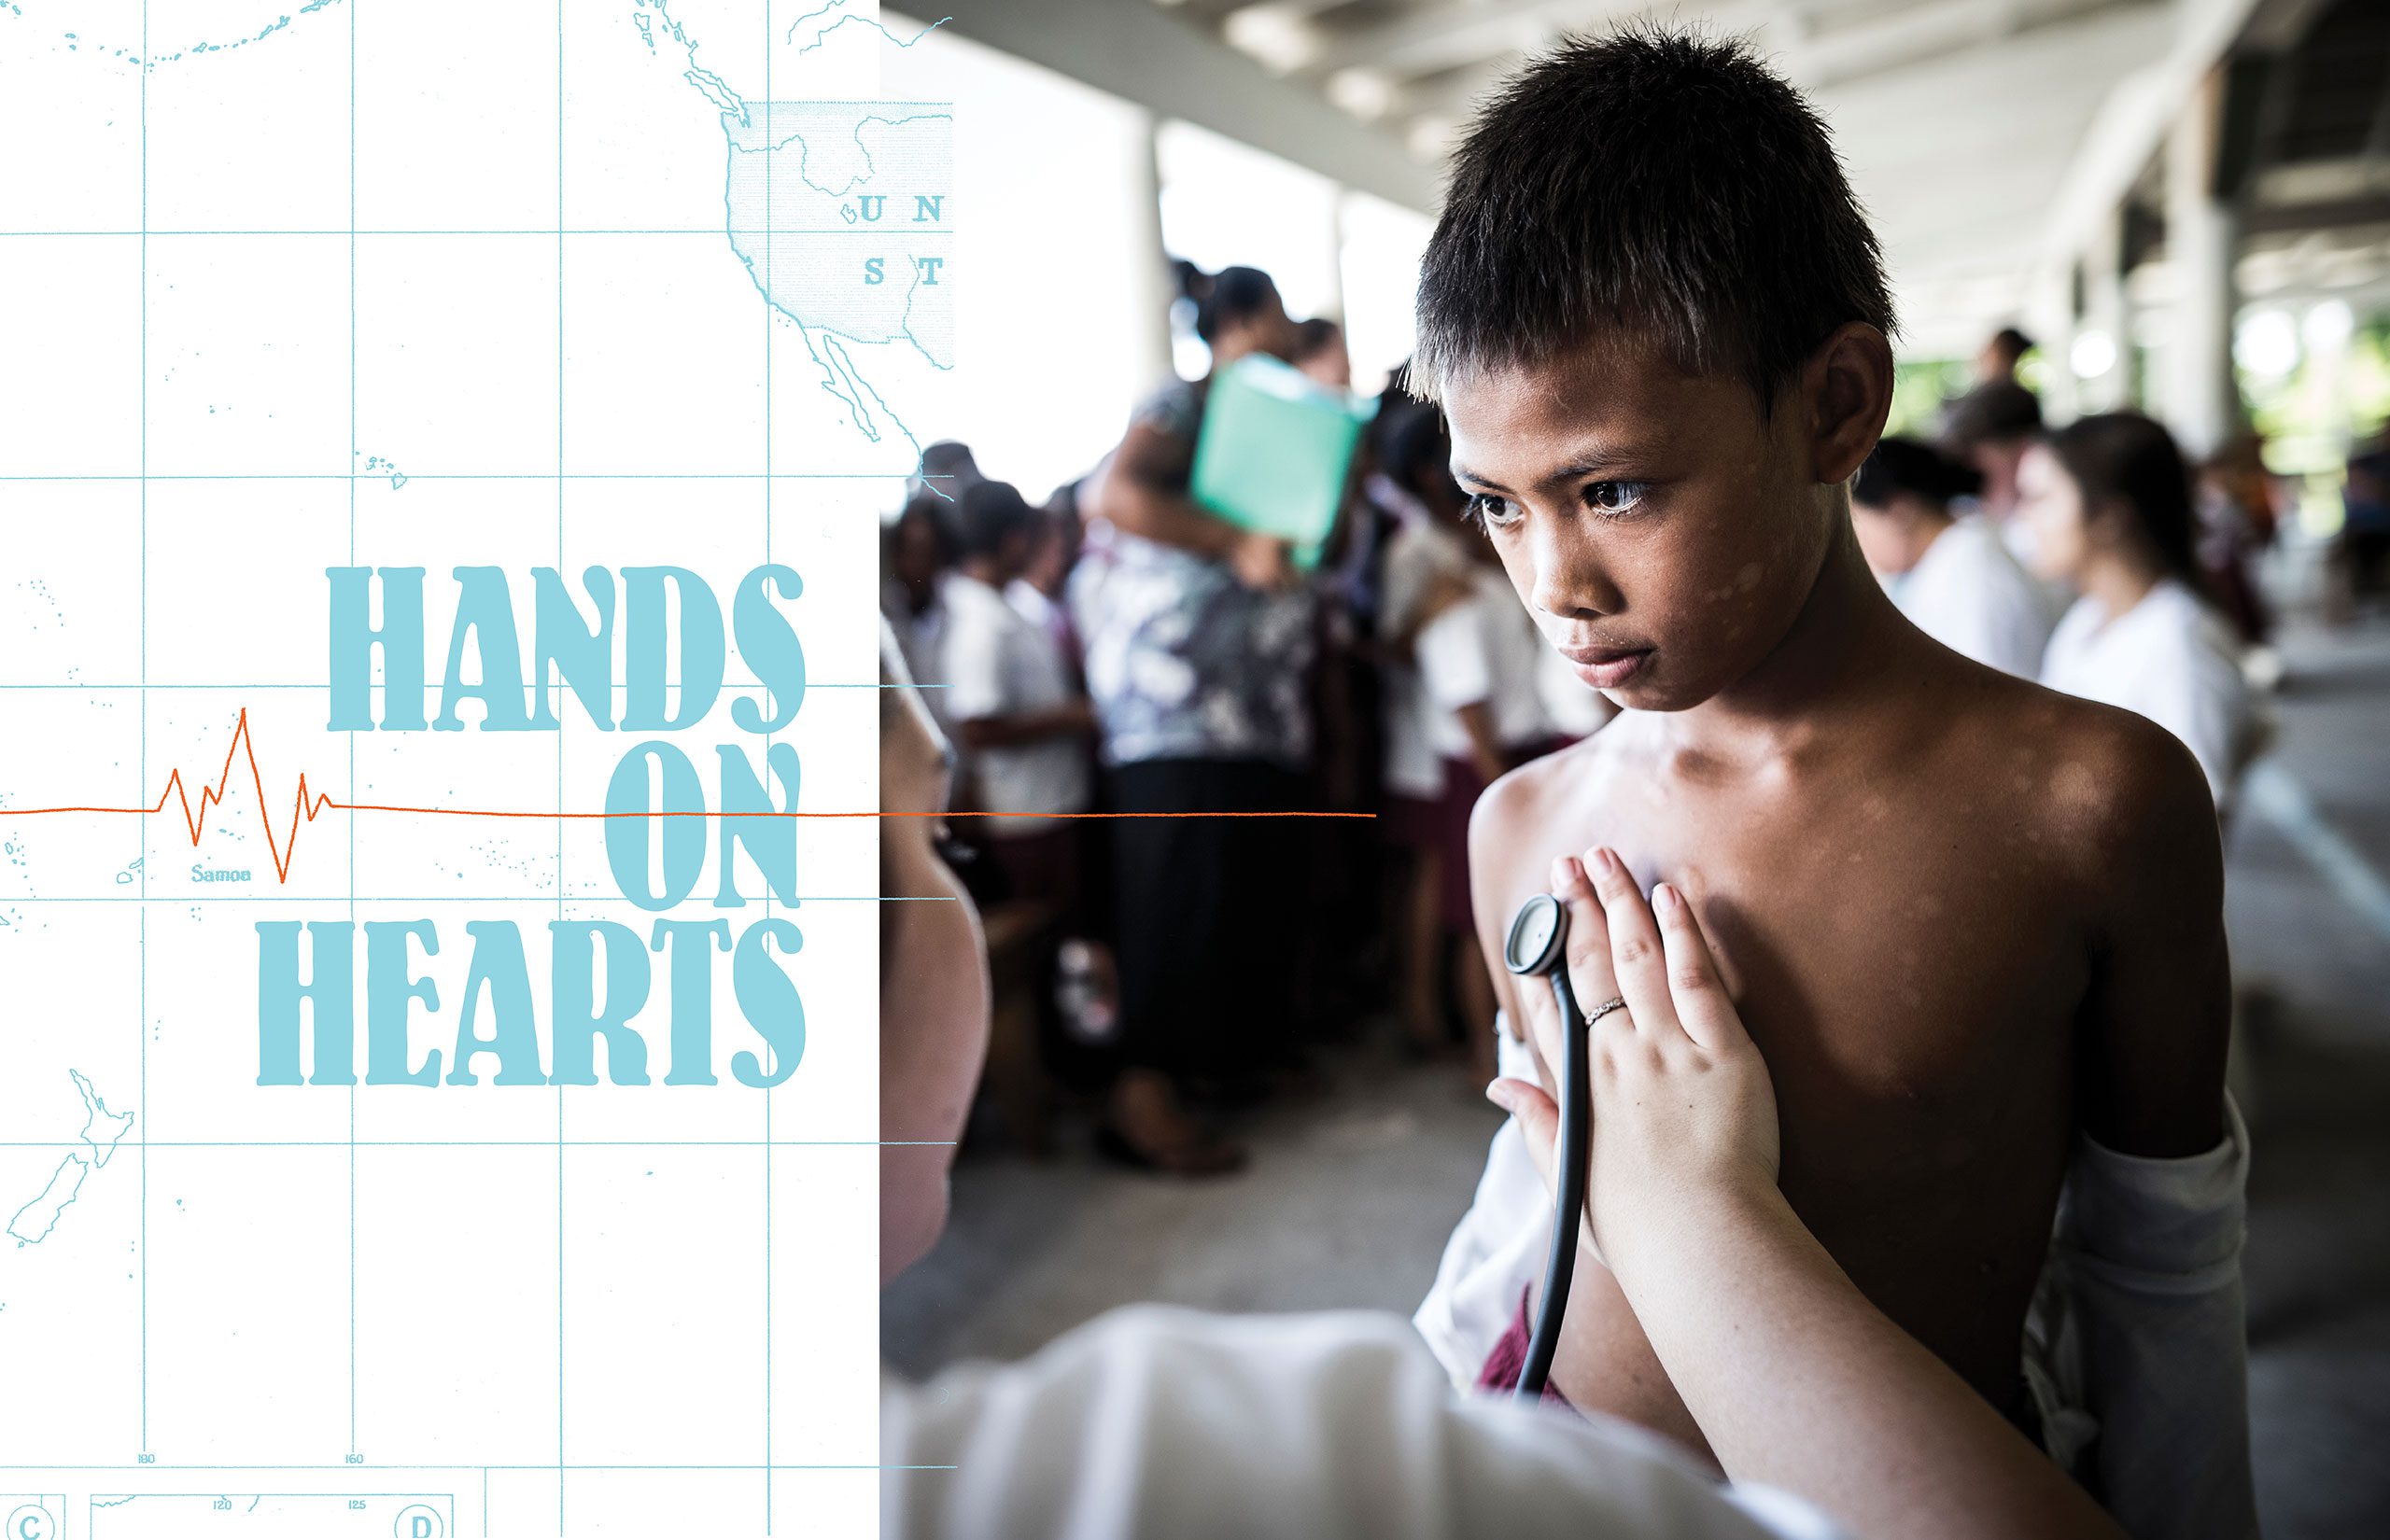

2041,578,2261,809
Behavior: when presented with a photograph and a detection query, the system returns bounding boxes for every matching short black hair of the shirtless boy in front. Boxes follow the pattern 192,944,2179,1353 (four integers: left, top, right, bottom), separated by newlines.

1413,24,1893,408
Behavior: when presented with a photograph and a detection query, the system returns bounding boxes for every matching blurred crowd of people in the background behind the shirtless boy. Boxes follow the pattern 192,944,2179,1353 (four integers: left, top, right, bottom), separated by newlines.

882,268,2361,1175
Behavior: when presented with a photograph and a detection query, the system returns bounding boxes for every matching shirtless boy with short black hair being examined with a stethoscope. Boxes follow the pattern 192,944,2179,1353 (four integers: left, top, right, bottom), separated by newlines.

1413,31,2237,1490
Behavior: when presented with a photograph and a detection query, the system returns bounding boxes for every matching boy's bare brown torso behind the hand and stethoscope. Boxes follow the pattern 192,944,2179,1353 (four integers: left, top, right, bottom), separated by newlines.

1503,745,2088,1447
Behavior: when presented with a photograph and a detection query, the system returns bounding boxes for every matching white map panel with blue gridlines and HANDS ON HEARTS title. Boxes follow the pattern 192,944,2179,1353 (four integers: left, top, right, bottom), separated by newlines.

0,0,918,1540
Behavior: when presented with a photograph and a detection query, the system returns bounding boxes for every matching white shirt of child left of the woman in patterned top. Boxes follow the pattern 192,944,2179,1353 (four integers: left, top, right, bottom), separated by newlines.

939,573,1090,833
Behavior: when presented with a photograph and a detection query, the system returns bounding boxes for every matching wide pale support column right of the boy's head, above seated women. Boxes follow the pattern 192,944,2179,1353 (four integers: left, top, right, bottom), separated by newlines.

2156,72,2240,461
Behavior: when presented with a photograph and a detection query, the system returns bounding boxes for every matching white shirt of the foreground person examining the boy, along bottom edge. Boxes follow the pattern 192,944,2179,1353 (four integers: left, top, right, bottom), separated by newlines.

879,1306,1840,1540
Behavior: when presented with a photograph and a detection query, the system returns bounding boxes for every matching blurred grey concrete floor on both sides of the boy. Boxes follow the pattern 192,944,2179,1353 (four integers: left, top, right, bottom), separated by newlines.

882,623,2390,1540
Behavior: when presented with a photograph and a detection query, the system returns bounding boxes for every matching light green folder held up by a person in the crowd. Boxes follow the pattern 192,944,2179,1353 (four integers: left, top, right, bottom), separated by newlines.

1190,354,1377,568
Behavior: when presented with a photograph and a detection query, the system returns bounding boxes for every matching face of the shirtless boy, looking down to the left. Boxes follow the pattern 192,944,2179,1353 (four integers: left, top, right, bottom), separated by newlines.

1446,342,1843,711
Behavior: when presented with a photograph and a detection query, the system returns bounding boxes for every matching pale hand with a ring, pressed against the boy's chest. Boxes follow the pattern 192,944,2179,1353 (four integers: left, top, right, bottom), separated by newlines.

1486,847,1778,1261
